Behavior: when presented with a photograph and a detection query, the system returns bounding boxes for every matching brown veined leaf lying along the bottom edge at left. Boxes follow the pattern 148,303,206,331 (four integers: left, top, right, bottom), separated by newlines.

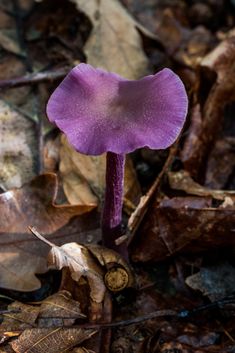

11,327,96,353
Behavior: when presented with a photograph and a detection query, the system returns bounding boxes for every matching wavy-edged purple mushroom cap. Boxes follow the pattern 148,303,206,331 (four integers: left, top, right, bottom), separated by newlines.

47,63,188,155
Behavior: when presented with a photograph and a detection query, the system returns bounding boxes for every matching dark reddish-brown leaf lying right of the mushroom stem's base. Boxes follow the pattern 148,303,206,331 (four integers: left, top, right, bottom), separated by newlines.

131,196,235,261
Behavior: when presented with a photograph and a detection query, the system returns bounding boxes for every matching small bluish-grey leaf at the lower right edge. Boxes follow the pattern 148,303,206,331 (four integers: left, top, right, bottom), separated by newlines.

186,263,235,302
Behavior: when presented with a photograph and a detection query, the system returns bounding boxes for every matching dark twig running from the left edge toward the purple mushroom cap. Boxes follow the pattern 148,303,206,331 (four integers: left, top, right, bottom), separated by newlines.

0,68,68,89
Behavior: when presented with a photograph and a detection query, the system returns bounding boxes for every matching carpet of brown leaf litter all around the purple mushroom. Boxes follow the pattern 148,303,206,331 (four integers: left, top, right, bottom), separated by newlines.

0,0,235,353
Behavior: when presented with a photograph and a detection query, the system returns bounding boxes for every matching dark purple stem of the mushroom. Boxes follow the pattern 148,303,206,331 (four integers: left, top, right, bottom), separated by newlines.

102,152,127,257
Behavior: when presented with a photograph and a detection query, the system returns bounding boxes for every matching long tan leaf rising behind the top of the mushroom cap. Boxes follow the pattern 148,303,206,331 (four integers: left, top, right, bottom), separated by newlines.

72,0,148,79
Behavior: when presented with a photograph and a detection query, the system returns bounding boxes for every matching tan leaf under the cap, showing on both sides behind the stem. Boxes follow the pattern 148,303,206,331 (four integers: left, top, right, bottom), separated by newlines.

60,135,141,208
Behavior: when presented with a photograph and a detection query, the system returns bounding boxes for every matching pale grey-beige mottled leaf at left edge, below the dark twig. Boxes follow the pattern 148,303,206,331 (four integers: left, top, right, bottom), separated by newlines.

0,100,36,190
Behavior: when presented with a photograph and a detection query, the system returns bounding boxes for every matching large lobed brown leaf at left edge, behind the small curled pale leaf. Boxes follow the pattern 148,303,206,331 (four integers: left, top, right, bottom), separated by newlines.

0,174,96,291
